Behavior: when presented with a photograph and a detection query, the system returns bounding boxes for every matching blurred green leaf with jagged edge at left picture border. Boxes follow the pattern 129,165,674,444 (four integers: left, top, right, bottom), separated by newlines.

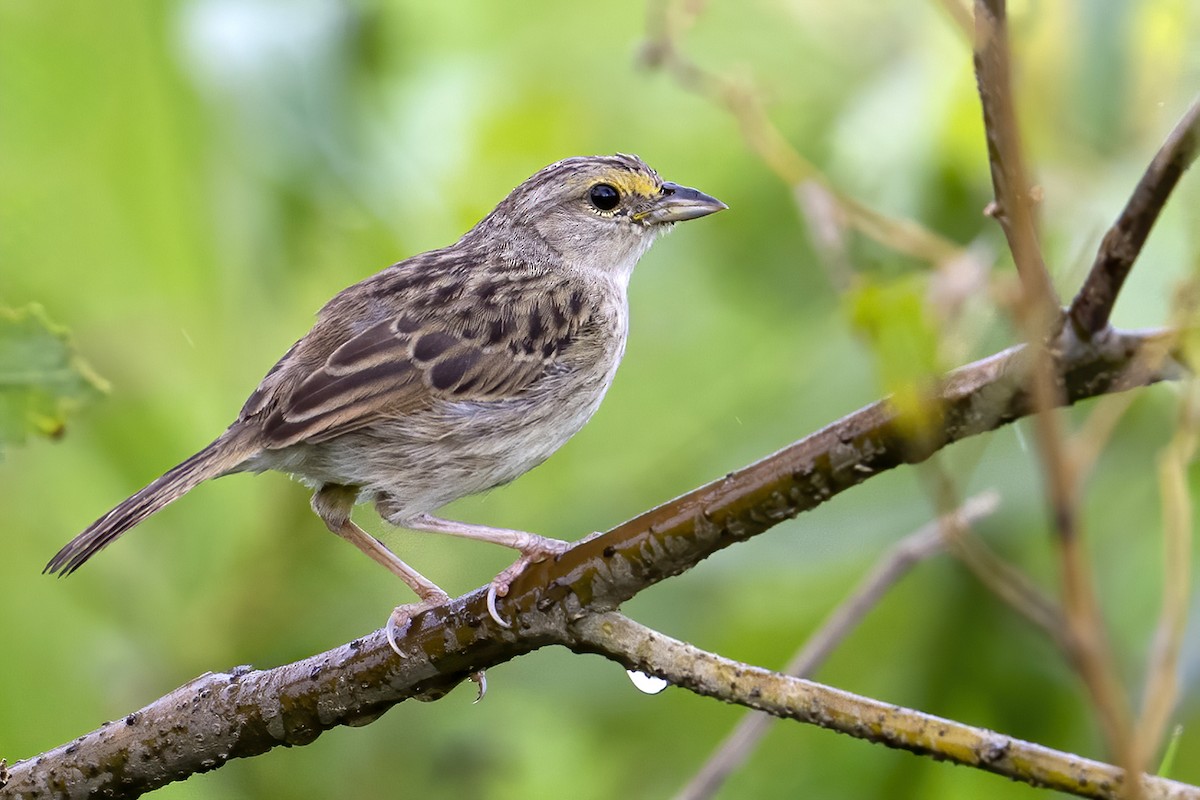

0,305,108,452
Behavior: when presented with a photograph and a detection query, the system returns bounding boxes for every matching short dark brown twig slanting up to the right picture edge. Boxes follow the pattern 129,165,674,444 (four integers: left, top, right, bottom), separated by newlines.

1068,98,1200,338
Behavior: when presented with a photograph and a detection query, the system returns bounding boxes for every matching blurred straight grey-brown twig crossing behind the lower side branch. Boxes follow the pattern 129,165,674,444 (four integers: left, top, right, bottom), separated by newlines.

676,492,1000,800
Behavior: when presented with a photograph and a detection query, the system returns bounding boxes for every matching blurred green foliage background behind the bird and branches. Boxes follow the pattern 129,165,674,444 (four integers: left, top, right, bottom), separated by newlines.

0,0,1200,799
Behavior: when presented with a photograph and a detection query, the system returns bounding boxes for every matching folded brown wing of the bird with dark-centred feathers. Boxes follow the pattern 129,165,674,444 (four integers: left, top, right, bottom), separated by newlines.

241,277,586,450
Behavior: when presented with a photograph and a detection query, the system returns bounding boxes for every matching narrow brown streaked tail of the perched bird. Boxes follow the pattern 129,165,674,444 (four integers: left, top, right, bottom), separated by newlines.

42,428,256,575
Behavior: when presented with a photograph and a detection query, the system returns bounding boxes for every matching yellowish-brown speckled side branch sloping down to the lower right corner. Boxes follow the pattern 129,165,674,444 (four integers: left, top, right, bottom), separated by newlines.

571,613,1200,800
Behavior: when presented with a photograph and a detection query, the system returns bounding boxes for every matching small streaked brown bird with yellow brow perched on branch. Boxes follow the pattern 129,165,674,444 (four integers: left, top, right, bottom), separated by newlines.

43,154,727,652
